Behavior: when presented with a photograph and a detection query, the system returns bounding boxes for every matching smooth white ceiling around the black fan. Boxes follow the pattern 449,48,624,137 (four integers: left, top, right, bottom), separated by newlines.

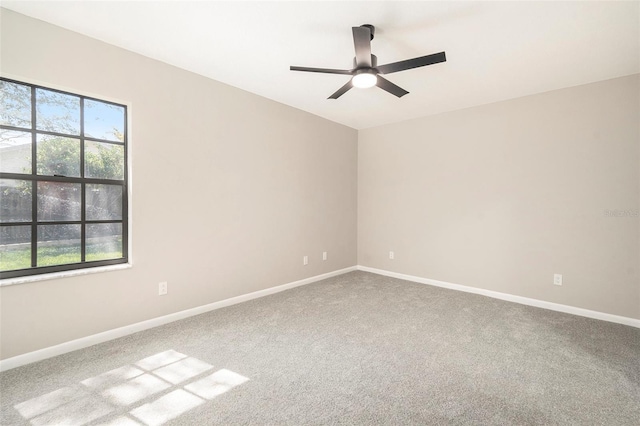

2,0,640,129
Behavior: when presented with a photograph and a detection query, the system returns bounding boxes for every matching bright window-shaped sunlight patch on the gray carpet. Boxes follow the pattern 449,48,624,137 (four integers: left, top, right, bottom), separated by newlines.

14,350,249,426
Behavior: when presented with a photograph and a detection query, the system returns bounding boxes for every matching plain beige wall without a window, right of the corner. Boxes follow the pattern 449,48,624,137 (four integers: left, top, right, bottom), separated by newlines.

358,75,640,318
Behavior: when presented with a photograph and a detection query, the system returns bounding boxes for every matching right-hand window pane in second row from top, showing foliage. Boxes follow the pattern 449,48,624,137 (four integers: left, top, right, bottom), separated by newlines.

84,141,124,180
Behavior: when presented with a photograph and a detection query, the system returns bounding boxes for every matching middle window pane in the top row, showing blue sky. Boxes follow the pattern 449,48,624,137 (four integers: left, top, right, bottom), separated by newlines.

36,89,80,135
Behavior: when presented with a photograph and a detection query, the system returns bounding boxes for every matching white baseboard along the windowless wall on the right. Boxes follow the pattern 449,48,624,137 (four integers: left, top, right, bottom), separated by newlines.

357,265,640,328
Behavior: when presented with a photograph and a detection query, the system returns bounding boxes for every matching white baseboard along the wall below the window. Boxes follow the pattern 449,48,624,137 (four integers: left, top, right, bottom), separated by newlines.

0,266,357,372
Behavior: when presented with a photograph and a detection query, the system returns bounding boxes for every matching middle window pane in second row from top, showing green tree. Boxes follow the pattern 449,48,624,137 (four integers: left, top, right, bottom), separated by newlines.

36,135,80,177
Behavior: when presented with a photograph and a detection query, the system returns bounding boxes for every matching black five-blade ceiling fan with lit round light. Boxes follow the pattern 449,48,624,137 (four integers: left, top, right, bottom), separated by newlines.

289,24,447,99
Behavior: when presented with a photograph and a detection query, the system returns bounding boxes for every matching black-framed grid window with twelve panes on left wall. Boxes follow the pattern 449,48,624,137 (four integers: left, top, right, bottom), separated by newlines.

0,78,128,278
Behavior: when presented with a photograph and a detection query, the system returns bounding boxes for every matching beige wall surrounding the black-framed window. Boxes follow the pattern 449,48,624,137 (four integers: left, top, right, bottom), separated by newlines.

0,9,357,359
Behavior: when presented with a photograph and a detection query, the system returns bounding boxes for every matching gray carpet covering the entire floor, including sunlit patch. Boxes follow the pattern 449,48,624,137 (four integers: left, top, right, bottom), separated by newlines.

0,272,640,425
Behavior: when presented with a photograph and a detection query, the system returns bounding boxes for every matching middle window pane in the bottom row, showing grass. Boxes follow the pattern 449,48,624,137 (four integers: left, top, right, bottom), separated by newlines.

37,225,81,266
